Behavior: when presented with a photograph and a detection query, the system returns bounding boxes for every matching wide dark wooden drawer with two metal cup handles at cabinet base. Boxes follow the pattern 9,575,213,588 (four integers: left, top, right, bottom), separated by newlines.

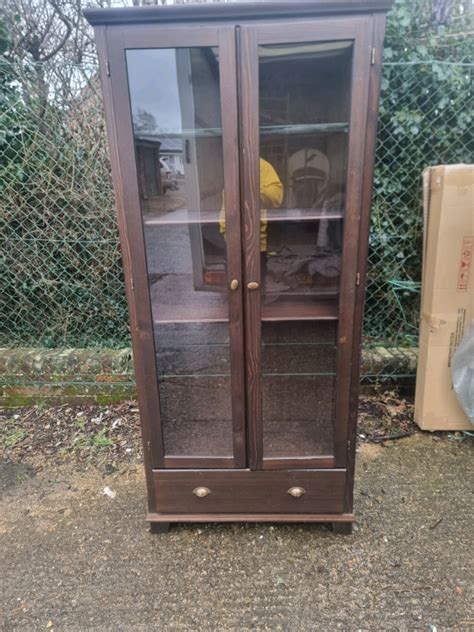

153,469,346,514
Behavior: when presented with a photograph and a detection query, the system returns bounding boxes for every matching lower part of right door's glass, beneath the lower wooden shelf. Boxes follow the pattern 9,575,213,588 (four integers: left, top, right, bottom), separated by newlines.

262,322,336,458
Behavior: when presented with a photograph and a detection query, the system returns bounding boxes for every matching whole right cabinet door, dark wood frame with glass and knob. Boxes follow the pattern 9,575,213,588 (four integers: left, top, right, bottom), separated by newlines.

241,18,370,469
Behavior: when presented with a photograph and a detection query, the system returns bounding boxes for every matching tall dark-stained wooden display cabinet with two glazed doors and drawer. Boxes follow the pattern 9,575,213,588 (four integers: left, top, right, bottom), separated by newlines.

86,0,390,532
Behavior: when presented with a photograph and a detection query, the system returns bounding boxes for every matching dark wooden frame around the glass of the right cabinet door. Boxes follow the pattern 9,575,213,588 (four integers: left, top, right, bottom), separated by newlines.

238,15,372,469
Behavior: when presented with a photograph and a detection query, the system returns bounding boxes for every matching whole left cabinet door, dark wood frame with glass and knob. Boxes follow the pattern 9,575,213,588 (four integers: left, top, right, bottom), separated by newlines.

106,27,245,467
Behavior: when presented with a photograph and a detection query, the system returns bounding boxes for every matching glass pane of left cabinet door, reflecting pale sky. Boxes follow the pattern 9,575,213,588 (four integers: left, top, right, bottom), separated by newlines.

126,47,234,459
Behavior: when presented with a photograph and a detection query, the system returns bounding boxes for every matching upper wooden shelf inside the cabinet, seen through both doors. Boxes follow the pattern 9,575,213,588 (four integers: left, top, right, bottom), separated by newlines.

143,208,344,226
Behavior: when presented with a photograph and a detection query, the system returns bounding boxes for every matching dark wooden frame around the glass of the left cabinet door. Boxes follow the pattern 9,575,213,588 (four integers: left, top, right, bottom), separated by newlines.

95,25,246,474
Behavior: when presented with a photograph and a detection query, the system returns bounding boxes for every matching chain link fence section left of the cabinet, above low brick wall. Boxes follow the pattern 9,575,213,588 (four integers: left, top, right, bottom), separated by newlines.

0,61,130,347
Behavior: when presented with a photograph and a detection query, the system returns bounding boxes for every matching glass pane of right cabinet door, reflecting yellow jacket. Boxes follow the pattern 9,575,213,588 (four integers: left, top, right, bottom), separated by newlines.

258,41,353,458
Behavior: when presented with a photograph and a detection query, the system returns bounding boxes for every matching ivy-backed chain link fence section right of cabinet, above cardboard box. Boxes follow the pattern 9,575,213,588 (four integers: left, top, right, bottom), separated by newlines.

364,55,474,347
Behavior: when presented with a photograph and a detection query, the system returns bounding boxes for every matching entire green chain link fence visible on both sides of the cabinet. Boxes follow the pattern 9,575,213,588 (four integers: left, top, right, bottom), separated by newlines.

0,53,474,378
